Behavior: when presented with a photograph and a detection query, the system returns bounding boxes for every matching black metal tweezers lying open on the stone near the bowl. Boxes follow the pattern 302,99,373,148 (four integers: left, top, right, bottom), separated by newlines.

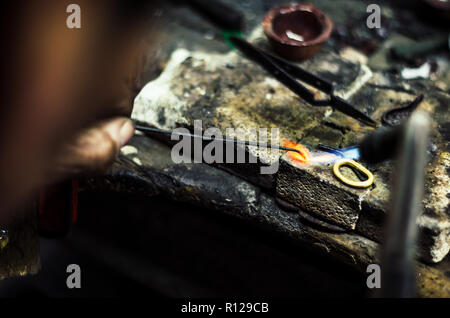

229,36,376,127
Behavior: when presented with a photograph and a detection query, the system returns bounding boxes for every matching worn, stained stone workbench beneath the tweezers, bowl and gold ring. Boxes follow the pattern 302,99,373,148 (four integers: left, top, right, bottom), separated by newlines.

0,0,450,297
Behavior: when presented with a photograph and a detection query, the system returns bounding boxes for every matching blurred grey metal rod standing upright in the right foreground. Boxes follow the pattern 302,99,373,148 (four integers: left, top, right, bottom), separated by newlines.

381,111,431,298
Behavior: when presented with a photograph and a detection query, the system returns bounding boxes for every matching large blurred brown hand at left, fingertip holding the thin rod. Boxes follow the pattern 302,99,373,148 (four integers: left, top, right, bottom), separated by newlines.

0,0,153,224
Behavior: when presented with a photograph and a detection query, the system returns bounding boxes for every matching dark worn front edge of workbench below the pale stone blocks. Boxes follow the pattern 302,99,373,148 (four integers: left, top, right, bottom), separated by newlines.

80,135,450,297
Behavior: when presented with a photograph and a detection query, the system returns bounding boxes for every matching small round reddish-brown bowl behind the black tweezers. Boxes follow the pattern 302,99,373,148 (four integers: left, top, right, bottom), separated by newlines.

262,3,333,60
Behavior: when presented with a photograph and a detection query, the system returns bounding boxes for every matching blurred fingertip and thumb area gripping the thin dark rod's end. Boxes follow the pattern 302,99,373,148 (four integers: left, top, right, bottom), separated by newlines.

51,117,134,182
